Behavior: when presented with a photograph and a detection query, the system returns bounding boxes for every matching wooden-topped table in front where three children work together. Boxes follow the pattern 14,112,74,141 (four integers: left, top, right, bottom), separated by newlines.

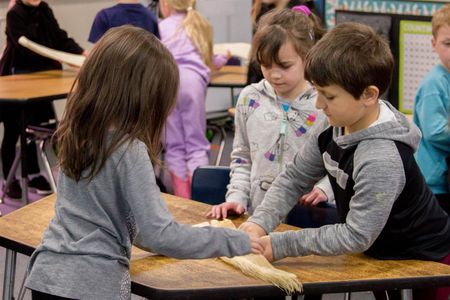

0,195,450,300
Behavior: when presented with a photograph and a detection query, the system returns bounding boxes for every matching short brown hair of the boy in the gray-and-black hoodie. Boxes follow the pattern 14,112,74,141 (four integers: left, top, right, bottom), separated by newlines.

305,22,394,99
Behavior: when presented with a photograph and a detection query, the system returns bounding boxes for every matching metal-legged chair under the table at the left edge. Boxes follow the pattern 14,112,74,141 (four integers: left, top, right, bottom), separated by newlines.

0,123,56,203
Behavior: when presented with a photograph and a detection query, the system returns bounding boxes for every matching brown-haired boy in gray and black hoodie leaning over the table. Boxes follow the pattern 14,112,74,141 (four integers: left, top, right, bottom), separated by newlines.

241,23,450,299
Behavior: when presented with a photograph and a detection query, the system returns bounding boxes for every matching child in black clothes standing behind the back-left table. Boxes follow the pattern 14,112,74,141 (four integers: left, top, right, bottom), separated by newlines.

0,0,86,198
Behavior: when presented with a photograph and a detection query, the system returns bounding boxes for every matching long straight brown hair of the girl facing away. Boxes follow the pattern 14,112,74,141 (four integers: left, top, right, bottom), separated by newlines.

56,26,179,181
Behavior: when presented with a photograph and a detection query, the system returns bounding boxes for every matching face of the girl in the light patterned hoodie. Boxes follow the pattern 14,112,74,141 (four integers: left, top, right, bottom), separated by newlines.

261,42,306,100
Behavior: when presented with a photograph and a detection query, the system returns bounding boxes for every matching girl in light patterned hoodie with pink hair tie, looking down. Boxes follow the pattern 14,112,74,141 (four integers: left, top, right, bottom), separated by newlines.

208,5,334,218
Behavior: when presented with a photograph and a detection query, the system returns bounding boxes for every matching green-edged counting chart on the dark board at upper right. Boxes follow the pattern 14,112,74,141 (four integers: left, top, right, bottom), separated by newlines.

398,20,439,114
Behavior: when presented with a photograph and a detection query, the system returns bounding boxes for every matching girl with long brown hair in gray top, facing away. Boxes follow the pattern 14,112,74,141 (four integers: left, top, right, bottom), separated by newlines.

25,26,263,300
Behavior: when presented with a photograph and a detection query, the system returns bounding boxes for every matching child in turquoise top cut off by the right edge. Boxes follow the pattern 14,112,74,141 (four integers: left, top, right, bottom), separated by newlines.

414,4,450,215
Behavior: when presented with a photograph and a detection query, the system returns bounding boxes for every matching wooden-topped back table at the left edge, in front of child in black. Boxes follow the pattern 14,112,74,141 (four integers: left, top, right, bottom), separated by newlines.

0,70,77,204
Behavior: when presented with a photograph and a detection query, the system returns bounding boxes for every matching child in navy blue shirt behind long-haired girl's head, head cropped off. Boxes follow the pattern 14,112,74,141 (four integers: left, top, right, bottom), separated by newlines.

88,0,159,43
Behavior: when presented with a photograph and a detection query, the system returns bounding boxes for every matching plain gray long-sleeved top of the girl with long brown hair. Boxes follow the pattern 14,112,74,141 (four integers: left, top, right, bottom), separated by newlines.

26,141,250,300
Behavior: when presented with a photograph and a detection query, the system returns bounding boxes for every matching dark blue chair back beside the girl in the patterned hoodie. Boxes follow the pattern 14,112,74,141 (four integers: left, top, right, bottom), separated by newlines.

192,166,230,205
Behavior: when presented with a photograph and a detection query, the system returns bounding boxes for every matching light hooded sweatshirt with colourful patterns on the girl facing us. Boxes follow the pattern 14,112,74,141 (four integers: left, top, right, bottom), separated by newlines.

226,79,334,213
